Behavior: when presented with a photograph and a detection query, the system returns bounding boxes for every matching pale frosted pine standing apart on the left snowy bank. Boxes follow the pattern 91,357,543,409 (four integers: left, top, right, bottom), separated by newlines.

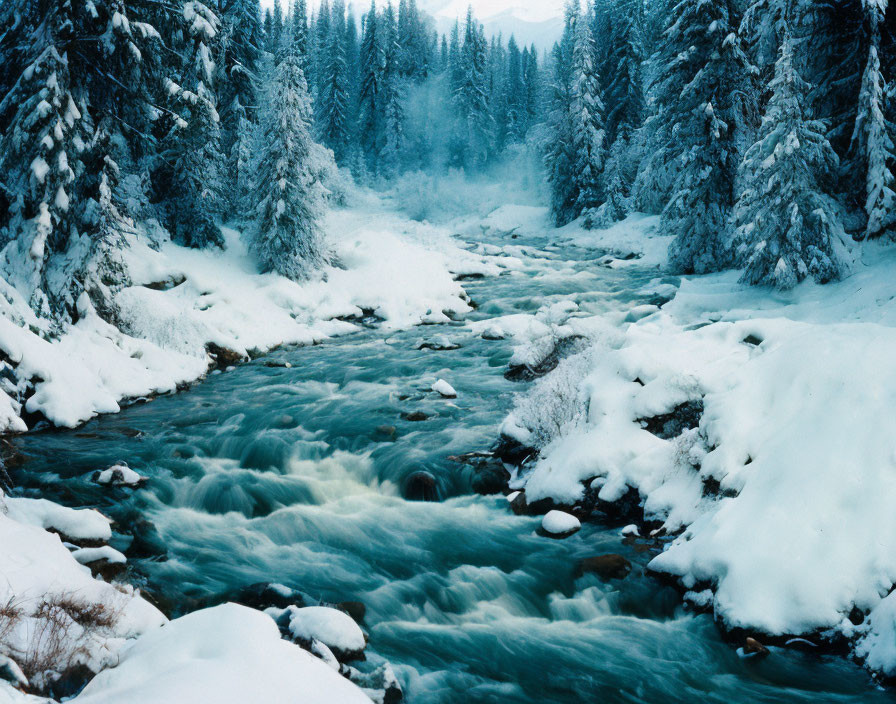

250,52,327,280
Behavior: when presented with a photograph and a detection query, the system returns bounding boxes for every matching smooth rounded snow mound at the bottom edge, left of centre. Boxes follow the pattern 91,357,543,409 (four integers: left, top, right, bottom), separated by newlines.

72,604,370,704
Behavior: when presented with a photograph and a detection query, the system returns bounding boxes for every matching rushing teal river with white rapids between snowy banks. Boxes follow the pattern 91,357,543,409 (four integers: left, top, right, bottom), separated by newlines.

8,228,892,704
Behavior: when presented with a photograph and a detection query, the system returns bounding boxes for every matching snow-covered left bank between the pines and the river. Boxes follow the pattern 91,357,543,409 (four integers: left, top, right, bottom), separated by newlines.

0,188,499,431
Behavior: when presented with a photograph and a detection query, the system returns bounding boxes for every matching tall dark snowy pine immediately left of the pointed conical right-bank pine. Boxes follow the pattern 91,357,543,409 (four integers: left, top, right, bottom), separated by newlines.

647,0,751,273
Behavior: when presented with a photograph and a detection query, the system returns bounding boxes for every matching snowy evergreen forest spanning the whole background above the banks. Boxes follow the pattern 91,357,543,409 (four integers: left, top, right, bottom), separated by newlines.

0,0,896,324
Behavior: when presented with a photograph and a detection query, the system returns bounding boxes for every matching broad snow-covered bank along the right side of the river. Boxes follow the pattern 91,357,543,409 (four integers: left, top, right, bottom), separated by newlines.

496,219,896,675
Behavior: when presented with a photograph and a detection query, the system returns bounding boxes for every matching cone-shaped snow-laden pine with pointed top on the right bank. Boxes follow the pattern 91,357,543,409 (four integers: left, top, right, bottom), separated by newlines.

734,24,842,288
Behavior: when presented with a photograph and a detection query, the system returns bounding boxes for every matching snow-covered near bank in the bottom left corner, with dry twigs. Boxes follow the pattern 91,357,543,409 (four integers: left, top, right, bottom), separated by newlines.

0,491,382,704
